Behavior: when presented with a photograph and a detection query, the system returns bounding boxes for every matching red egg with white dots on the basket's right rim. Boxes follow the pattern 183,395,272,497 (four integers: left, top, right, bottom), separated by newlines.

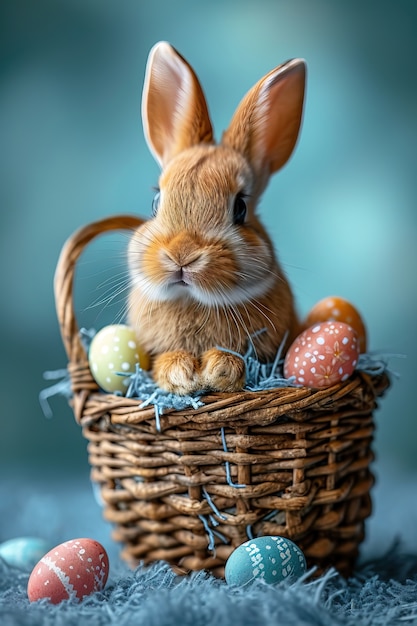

284,322,359,389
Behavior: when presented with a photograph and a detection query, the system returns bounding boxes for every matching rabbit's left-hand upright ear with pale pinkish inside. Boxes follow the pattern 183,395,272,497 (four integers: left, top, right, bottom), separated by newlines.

142,41,213,167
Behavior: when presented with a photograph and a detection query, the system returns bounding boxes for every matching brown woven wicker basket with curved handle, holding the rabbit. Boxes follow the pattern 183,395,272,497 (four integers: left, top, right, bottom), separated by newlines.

55,216,389,576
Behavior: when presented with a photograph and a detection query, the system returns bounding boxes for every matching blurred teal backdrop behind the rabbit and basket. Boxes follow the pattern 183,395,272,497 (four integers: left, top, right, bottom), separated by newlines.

0,0,417,476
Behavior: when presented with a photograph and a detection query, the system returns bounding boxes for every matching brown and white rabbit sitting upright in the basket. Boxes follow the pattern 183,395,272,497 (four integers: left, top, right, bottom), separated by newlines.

128,42,305,394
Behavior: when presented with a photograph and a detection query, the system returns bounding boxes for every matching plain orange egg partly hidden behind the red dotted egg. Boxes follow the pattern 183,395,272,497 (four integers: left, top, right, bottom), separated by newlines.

305,296,367,353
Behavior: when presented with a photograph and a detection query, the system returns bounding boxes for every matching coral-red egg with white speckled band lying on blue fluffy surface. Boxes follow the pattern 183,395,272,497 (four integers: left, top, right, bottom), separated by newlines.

27,539,109,604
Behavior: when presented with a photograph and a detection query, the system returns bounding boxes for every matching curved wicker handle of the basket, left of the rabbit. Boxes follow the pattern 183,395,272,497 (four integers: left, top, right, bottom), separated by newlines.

54,215,145,363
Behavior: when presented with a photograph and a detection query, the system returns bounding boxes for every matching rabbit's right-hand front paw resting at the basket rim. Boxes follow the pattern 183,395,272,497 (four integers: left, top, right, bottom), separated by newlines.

200,348,245,391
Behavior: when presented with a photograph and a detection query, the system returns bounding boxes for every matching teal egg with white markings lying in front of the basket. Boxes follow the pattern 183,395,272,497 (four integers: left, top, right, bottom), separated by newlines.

224,536,307,585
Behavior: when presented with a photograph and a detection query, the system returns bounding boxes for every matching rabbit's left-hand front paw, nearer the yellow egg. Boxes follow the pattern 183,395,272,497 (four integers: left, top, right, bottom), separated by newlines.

153,350,201,396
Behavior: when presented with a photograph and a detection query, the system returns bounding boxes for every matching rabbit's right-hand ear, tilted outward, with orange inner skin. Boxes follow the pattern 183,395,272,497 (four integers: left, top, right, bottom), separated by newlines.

222,59,306,191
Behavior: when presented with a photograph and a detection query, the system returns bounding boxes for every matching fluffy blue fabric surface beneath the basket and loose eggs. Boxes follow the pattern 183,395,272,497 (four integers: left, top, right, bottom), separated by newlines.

0,470,417,626
